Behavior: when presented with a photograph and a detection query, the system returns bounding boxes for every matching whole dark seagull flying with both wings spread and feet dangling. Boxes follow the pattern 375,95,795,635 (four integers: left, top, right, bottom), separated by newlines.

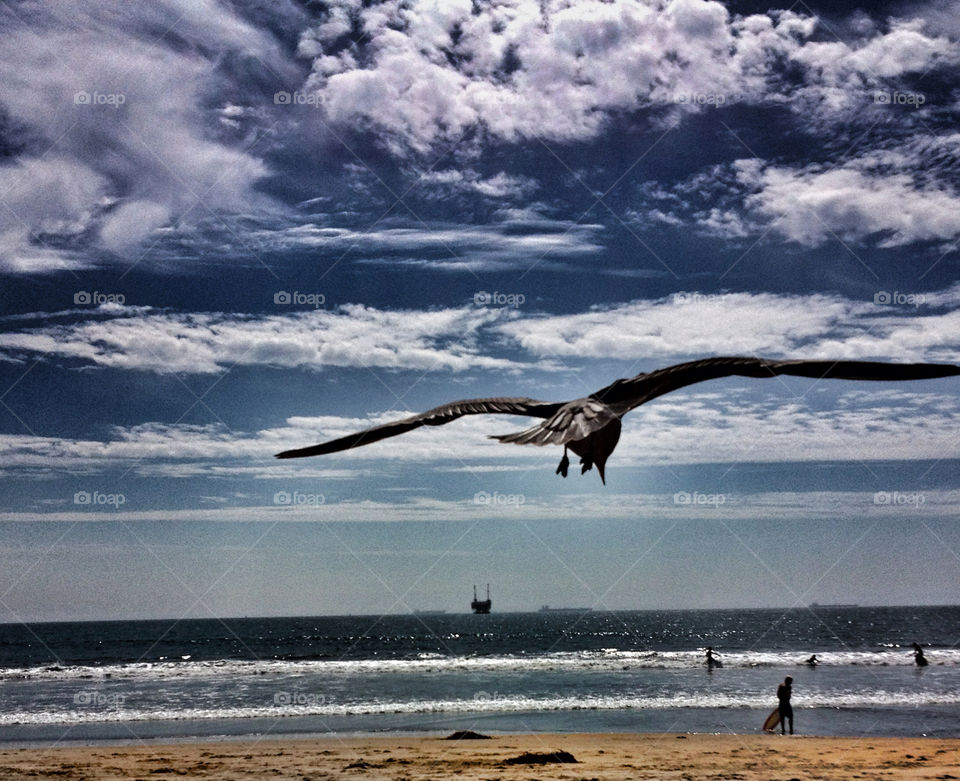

276,357,960,485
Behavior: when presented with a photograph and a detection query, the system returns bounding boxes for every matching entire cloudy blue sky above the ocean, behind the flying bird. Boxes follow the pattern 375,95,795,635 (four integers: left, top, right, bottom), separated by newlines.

0,0,960,622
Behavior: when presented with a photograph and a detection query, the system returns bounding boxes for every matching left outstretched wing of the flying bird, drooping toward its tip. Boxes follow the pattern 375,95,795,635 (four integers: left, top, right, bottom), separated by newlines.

276,397,563,458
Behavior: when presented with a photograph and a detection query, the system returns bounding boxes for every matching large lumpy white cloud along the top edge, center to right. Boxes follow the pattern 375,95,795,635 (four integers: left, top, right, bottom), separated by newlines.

300,0,956,153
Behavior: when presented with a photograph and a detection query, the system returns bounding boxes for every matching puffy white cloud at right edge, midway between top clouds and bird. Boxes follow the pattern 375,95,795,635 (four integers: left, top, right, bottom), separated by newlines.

629,133,960,249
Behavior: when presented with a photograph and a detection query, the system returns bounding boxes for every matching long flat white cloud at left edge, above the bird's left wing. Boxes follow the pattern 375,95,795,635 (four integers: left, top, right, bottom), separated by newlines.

0,304,540,374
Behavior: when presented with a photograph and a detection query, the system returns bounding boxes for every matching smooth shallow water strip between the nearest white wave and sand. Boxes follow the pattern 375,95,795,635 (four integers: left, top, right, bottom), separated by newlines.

7,702,960,748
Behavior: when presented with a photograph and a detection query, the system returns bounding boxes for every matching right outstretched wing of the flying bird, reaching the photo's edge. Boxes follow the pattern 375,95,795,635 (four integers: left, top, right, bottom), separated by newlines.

591,357,960,415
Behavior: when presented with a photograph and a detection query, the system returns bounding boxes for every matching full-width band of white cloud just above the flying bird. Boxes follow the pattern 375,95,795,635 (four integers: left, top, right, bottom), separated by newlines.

0,286,960,374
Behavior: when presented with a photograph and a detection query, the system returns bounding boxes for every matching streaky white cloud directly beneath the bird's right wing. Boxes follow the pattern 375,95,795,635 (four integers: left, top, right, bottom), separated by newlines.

611,380,960,466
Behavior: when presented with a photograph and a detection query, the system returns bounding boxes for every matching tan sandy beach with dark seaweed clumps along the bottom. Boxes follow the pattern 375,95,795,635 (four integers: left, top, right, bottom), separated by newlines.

0,734,960,781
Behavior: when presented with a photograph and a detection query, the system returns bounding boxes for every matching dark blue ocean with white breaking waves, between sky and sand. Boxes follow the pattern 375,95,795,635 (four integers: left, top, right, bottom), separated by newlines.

0,606,960,746
